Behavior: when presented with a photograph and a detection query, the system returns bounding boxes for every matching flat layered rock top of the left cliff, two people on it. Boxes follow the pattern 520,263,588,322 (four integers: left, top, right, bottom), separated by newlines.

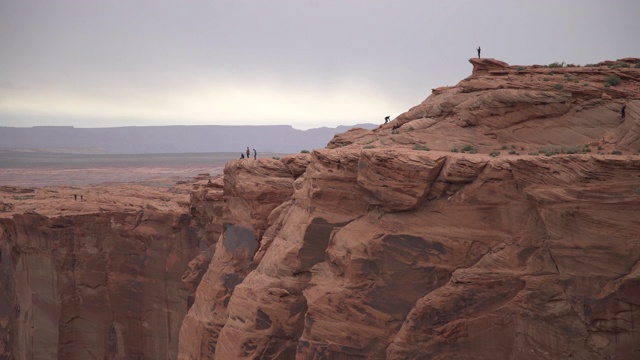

0,180,206,218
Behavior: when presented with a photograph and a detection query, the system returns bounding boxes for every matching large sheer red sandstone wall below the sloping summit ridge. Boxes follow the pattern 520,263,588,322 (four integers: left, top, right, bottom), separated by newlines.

180,148,640,359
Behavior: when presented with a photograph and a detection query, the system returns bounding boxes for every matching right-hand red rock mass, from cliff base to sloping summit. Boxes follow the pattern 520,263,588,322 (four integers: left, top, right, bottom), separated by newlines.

179,59,640,359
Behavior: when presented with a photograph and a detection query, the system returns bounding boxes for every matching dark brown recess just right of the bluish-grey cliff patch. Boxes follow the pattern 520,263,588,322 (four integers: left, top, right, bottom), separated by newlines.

298,218,348,271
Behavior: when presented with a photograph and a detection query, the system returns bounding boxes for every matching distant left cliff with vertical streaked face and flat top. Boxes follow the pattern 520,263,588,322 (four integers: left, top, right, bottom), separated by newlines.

0,187,198,359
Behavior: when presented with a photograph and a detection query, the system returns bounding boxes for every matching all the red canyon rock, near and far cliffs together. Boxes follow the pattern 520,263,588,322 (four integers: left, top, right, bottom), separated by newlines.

0,58,640,359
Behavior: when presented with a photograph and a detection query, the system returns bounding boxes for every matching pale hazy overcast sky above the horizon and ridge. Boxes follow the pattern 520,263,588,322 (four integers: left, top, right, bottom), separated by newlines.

0,0,640,128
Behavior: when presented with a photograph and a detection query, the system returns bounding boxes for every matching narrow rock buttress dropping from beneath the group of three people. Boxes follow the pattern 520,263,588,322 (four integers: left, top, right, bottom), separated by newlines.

179,156,308,359
